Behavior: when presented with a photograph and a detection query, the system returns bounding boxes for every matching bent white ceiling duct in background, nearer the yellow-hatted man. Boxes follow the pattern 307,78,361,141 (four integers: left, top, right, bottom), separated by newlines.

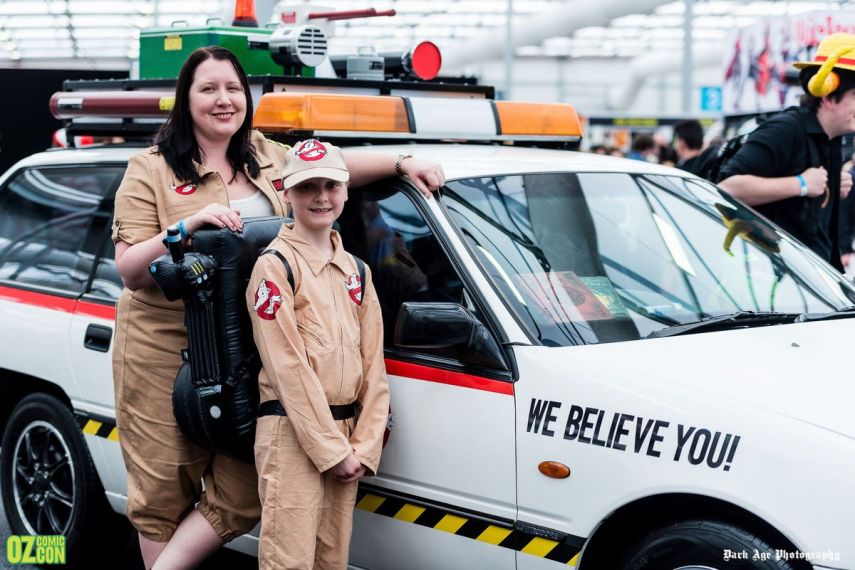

608,42,722,110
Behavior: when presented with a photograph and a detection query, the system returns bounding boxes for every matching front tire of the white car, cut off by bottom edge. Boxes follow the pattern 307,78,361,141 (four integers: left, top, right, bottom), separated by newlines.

620,521,796,570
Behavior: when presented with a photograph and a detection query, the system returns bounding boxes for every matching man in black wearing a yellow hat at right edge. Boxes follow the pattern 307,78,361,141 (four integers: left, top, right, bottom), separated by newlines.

719,33,855,269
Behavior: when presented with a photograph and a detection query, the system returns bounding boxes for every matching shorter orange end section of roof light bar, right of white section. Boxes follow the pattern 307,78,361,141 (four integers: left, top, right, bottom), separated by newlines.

496,101,582,137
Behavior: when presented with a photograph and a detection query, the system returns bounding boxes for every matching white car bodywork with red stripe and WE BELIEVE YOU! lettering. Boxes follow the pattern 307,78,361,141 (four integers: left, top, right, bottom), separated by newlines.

0,145,855,570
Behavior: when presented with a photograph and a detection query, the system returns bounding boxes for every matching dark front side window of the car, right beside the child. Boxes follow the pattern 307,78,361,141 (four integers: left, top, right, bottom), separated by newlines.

339,190,483,358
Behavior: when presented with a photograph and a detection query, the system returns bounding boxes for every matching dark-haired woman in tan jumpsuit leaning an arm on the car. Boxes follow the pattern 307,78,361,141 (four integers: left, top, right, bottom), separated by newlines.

113,47,444,568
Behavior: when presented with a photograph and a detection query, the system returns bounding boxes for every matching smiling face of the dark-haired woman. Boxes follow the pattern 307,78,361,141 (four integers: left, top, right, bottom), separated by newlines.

189,58,246,143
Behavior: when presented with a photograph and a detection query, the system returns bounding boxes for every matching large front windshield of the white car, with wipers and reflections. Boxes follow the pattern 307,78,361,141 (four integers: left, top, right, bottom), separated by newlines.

442,173,855,346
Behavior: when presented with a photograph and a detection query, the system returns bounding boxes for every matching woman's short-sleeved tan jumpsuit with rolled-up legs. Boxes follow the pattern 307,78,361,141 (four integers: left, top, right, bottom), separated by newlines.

113,133,286,542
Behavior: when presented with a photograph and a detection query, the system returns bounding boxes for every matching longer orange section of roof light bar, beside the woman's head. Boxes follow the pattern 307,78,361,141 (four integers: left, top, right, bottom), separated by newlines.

253,92,410,133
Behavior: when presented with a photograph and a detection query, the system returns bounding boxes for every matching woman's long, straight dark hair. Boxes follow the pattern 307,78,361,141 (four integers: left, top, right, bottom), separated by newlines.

155,46,260,184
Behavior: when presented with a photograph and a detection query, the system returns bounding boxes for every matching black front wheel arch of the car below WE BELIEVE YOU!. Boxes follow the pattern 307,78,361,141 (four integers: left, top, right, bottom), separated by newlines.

580,493,811,570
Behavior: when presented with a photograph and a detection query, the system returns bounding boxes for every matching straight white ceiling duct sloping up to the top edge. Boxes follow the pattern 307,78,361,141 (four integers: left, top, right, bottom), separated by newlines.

442,0,673,72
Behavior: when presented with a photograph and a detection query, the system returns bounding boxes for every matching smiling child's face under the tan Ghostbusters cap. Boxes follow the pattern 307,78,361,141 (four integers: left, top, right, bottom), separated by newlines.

283,178,347,230
